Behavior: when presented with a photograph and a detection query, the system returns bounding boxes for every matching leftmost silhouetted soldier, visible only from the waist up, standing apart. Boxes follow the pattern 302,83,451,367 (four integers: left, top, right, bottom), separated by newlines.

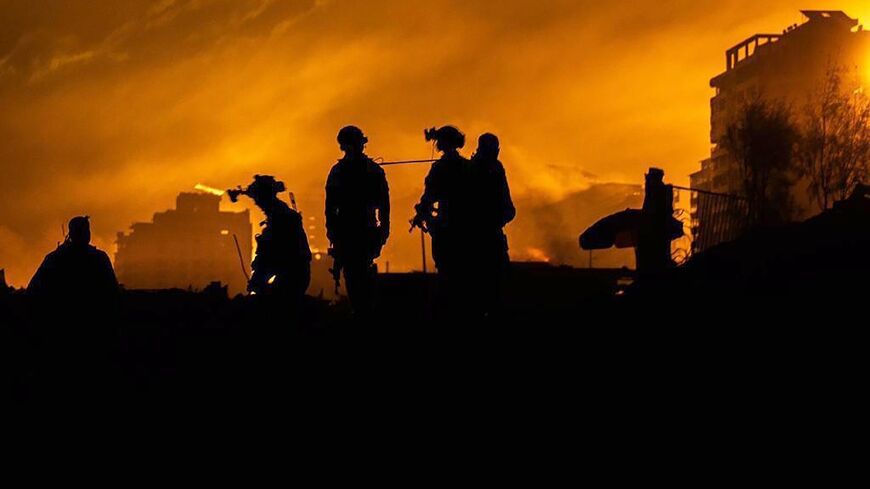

27,216,118,306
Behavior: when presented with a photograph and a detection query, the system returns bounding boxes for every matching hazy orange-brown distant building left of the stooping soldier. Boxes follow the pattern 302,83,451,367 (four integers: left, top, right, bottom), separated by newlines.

115,193,252,294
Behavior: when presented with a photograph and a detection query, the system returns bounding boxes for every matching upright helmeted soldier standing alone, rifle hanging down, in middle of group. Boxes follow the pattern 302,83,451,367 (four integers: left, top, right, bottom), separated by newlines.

326,126,390,315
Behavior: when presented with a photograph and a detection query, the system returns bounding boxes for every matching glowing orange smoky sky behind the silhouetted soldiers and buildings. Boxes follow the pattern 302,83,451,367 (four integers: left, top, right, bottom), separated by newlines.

0,0,870,285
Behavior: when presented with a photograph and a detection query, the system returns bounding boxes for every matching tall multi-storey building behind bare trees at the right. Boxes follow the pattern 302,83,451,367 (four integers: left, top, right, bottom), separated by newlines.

690,10,870,251
